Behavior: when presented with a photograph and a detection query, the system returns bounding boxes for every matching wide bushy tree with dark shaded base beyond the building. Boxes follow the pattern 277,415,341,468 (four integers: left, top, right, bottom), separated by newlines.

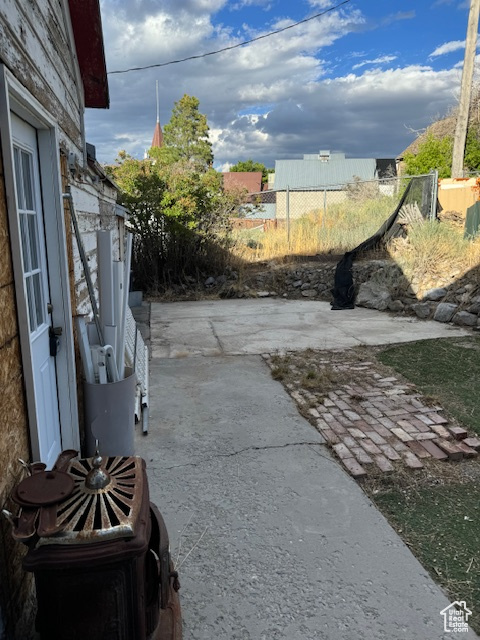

105,149,238,292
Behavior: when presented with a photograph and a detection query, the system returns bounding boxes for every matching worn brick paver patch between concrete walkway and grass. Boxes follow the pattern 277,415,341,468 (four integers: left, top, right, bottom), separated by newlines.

265,356,480,478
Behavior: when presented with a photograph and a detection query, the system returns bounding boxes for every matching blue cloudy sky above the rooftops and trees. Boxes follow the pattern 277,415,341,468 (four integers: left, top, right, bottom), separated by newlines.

86,0,469,171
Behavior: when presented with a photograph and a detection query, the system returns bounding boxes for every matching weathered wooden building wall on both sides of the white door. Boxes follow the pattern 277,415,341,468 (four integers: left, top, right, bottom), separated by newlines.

0,0,119,640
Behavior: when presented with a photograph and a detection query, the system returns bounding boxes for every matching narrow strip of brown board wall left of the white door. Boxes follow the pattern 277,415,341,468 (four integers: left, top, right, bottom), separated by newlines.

0,139,33,640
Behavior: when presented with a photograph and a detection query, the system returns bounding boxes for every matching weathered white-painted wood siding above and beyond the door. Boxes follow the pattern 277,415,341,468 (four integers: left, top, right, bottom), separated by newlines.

0,0,123,313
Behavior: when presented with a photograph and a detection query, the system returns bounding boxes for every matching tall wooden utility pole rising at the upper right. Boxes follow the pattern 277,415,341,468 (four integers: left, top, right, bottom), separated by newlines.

452,0,480,178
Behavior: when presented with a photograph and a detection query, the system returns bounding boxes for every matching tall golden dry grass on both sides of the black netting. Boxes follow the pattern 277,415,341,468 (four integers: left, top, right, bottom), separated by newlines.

233,196,480,279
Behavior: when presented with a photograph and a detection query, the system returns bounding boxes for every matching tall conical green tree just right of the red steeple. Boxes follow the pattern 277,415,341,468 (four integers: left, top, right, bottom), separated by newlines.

163,94,213,170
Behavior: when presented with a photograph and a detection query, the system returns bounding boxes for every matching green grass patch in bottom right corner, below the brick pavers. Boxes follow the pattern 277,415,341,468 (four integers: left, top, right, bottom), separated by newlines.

372,479,480,631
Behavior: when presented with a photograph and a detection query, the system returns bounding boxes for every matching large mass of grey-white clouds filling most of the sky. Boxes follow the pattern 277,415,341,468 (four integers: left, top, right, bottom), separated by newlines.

86,0,460,166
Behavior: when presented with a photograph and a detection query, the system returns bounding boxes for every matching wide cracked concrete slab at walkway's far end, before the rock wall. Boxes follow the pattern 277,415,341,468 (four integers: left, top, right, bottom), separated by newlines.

151,299,469,358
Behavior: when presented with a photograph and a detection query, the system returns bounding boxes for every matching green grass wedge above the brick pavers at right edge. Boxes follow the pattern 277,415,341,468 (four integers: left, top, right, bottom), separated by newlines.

377,337,480,434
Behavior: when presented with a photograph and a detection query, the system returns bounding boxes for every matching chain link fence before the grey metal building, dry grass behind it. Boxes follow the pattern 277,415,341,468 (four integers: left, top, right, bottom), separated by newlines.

235,172,438,257
